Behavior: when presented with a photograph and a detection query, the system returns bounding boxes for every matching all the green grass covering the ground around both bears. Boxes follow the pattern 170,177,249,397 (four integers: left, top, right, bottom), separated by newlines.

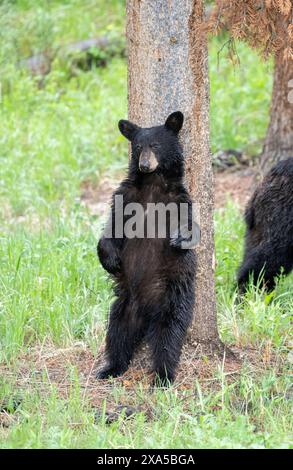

0,0,293,448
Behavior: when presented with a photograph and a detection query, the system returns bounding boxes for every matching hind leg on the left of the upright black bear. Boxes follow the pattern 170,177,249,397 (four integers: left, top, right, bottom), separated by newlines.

97,298,142,379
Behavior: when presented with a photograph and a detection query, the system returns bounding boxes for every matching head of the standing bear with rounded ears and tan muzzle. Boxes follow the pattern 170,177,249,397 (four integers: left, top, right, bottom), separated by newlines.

118,111,184,176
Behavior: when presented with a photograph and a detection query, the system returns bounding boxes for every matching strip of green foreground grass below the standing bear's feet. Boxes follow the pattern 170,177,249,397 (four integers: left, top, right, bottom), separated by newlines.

2,371,291,448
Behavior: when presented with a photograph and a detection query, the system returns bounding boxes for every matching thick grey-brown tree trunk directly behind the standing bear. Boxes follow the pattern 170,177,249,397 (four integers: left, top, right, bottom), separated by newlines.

127,0,222,351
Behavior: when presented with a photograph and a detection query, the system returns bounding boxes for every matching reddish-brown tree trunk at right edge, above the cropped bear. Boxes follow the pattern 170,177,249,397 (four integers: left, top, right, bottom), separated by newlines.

260,56,293,175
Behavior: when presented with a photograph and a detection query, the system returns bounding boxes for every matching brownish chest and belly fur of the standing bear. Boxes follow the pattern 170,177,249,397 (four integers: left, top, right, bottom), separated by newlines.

121,176,187,299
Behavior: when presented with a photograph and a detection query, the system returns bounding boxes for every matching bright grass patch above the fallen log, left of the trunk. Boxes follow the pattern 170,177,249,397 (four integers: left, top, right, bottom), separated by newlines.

0,0,124,61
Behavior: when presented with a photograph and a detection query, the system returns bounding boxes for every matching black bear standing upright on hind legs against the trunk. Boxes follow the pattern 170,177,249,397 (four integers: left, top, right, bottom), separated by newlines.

97,111,198,386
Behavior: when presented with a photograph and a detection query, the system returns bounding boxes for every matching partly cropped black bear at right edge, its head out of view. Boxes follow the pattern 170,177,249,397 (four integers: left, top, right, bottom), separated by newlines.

238,157,293,292
